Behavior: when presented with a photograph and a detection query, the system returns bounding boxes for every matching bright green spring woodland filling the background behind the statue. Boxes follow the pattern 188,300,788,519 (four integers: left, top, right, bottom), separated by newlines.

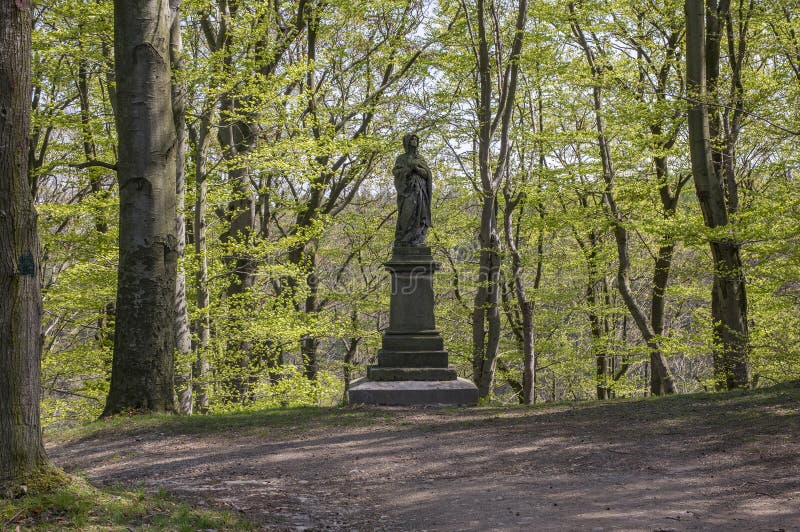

29,0,800,424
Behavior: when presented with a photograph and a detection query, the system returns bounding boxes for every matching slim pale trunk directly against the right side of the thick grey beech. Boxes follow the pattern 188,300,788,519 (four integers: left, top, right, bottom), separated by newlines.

169,0,192,414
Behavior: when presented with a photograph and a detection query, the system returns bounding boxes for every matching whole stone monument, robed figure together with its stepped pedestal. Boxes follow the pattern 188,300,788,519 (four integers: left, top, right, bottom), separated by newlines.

347,134,478,405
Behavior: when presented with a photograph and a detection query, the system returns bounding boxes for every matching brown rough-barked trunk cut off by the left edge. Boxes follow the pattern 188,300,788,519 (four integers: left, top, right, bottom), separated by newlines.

0,0,47,486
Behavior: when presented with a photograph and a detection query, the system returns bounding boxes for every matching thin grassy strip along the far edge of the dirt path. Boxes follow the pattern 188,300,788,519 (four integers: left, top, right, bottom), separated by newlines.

45,381,800,443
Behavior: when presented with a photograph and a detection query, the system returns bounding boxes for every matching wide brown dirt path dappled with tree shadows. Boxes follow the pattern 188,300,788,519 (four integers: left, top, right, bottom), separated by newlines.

49,386,800,531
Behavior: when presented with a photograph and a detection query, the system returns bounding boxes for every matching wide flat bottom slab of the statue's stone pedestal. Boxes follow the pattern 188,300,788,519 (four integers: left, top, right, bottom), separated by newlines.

349,378,478,406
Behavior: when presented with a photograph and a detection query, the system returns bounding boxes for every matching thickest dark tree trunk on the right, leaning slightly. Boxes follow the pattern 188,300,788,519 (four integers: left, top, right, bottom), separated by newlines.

684,0,750,389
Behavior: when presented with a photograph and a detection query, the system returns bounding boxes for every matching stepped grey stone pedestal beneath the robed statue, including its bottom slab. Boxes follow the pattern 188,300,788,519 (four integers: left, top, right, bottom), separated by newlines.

349,247,478,405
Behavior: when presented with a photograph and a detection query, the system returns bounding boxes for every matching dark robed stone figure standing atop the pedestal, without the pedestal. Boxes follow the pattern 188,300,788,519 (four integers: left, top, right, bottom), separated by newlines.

392,133,432,247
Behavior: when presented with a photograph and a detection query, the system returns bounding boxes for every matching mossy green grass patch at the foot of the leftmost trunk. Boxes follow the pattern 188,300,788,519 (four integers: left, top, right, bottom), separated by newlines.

0,468,255,531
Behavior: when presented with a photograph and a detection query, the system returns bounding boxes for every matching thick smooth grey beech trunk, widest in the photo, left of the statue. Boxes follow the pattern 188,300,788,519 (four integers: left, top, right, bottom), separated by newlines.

103,0,177,415
